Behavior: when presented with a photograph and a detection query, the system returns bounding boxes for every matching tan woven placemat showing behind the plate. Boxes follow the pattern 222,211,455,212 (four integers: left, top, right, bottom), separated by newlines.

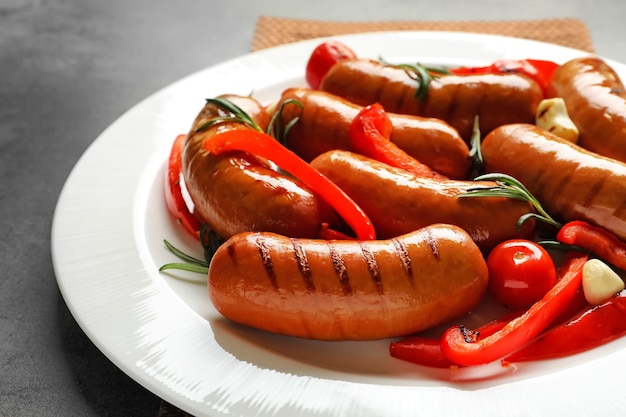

252,16,594,52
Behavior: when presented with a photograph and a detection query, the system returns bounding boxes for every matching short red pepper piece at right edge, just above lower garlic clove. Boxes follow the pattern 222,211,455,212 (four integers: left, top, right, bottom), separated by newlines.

556,220,626,269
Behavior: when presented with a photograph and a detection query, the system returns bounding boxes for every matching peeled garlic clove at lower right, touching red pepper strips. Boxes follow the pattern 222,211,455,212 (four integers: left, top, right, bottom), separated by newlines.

583,259,624,305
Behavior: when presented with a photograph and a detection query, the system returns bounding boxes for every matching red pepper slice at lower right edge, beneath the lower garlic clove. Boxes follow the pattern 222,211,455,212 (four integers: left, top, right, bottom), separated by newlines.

504,294,626,362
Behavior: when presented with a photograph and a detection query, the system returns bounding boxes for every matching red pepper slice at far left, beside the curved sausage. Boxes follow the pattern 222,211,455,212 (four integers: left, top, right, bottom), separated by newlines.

165,135,202,239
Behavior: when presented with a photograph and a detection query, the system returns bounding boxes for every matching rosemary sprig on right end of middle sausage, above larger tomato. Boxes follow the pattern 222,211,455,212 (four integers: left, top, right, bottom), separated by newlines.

460,173,561,228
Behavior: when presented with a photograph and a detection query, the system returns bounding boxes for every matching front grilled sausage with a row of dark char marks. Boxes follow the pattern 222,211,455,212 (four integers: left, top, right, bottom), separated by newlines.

208,225,488,340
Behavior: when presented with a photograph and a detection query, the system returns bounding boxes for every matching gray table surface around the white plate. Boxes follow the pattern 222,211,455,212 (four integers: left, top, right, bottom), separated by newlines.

0,0,626,417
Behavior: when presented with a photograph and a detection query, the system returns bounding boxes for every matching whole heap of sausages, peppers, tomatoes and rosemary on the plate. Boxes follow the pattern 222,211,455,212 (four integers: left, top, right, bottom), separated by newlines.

161,41,626,369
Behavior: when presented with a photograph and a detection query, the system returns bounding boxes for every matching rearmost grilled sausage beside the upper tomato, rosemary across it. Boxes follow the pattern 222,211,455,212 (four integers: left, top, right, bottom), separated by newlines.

320,59,543,141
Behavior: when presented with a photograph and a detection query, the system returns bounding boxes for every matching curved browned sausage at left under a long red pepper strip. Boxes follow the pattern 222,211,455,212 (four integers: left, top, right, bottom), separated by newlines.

183,95,335,238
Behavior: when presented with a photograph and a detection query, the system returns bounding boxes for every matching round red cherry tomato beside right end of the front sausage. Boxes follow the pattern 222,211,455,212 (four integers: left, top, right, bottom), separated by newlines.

487,239,556,309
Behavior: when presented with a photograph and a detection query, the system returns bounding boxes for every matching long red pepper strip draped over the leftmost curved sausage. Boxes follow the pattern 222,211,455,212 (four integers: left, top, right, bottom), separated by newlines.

204,129,376,240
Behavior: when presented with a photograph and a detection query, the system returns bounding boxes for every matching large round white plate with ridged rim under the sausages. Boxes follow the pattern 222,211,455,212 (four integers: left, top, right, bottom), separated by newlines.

52,32,626,417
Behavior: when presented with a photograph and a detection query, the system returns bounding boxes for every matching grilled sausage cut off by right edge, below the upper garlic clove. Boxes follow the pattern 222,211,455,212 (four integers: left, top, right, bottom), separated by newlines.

482,124,626,240
